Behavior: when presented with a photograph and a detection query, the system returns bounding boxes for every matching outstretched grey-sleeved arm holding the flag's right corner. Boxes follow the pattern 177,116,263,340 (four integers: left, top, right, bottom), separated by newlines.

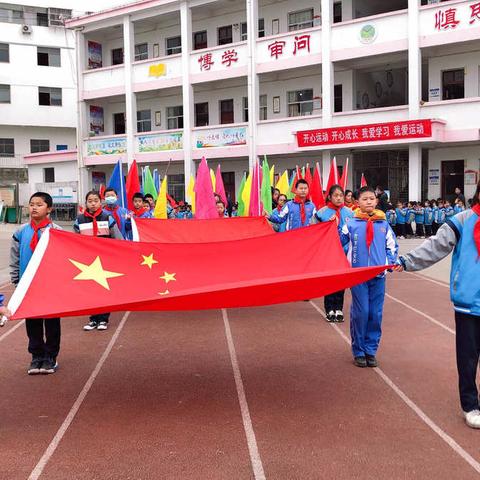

400,221,460,272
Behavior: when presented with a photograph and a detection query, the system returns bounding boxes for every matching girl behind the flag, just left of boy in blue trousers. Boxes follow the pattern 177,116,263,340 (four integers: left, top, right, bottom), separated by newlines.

315,185,353,322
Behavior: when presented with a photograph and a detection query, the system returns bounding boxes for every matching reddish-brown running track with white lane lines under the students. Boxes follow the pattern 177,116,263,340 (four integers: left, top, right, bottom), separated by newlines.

0,274,480,480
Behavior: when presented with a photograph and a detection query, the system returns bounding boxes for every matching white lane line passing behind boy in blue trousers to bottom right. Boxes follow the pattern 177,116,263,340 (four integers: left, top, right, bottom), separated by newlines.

310,301,480,473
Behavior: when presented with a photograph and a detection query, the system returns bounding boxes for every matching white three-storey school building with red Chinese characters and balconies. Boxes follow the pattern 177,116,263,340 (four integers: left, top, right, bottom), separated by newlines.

27,0,480,204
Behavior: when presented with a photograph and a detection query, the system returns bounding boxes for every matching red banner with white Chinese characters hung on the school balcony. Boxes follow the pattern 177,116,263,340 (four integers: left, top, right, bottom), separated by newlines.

297,120,432,147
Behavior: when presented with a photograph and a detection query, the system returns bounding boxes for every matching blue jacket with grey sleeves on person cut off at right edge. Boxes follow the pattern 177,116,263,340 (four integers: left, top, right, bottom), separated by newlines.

400,210,480,316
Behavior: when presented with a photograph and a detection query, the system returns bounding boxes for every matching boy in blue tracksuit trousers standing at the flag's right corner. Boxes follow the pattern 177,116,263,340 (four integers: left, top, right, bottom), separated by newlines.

341,187,398,367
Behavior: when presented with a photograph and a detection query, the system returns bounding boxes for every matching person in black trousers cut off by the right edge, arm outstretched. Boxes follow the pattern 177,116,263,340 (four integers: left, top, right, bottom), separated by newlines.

399,182,480,428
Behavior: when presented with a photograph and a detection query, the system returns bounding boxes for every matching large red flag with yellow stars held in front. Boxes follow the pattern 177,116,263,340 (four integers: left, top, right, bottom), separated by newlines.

9,222,388,319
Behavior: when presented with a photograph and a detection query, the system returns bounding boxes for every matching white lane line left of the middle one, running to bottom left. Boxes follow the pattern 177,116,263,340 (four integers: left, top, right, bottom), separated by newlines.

28,312,130,480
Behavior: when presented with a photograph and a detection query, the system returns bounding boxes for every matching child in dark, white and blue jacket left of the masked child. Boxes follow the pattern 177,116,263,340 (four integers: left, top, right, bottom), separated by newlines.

73,190,123,331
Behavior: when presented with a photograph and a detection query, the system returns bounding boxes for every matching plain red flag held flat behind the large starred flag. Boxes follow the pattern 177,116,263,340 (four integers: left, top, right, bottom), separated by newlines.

132,217,273,243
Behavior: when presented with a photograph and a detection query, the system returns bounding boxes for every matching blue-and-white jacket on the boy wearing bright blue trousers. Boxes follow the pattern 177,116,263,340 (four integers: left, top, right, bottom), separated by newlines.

340,213,398,276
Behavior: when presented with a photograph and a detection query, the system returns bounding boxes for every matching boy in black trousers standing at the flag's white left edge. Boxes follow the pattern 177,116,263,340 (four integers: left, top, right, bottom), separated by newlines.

10,192,61,375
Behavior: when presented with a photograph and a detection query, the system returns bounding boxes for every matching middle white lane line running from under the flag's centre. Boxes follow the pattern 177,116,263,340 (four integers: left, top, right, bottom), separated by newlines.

222,309,266,480
